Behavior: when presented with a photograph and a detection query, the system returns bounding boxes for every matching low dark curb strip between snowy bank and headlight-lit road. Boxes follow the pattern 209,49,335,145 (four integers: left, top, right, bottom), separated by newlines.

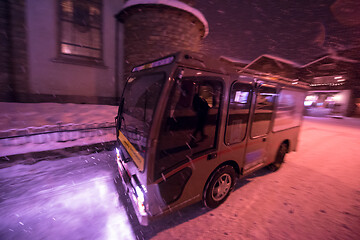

0,141,116,169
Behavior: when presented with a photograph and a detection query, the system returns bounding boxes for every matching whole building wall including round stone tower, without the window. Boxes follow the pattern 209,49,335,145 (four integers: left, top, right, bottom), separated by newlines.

0,0,205,104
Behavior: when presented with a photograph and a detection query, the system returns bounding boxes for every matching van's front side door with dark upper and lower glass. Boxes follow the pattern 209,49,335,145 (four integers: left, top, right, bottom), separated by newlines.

154,69,223,204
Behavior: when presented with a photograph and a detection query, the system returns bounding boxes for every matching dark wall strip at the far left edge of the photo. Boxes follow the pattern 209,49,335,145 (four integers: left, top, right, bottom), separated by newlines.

0,0,29,101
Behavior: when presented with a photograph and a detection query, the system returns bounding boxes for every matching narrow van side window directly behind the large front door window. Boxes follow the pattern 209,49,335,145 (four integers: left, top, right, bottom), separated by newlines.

225,82,252,145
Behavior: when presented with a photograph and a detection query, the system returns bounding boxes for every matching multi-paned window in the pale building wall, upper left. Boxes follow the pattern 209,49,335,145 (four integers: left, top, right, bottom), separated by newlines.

59,0,103,63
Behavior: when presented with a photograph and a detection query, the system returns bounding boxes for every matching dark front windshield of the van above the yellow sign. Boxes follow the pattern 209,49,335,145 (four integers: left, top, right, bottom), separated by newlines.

121,73,165,157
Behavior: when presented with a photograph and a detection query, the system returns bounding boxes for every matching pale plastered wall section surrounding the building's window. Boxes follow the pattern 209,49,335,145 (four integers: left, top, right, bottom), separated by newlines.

26,0,123,104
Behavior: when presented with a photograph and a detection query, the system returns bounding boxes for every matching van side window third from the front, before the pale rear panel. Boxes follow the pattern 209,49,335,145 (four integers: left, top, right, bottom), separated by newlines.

251,86,276,137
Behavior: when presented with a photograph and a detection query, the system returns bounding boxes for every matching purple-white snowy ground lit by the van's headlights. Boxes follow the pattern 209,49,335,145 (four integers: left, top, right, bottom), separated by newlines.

0,152,135,240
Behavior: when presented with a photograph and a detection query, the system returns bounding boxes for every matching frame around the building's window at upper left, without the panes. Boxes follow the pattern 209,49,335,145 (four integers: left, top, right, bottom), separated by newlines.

53,0,106,68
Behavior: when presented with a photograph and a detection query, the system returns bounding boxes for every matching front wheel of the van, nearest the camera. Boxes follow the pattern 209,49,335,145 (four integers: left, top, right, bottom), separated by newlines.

203,165,236,208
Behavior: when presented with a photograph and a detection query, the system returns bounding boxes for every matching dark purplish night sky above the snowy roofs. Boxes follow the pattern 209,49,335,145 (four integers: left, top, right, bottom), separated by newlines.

194,0,360,64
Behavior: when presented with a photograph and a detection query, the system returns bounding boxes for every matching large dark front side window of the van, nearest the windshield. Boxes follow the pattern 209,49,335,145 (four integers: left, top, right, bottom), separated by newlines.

155,76,222,178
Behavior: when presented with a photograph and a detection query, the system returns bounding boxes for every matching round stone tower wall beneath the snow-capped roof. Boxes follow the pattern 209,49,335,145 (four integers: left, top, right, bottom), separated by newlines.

119,5,204,73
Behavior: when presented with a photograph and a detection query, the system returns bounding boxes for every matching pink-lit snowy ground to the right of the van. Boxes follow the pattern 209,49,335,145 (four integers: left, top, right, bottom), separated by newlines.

143,117,360,240
